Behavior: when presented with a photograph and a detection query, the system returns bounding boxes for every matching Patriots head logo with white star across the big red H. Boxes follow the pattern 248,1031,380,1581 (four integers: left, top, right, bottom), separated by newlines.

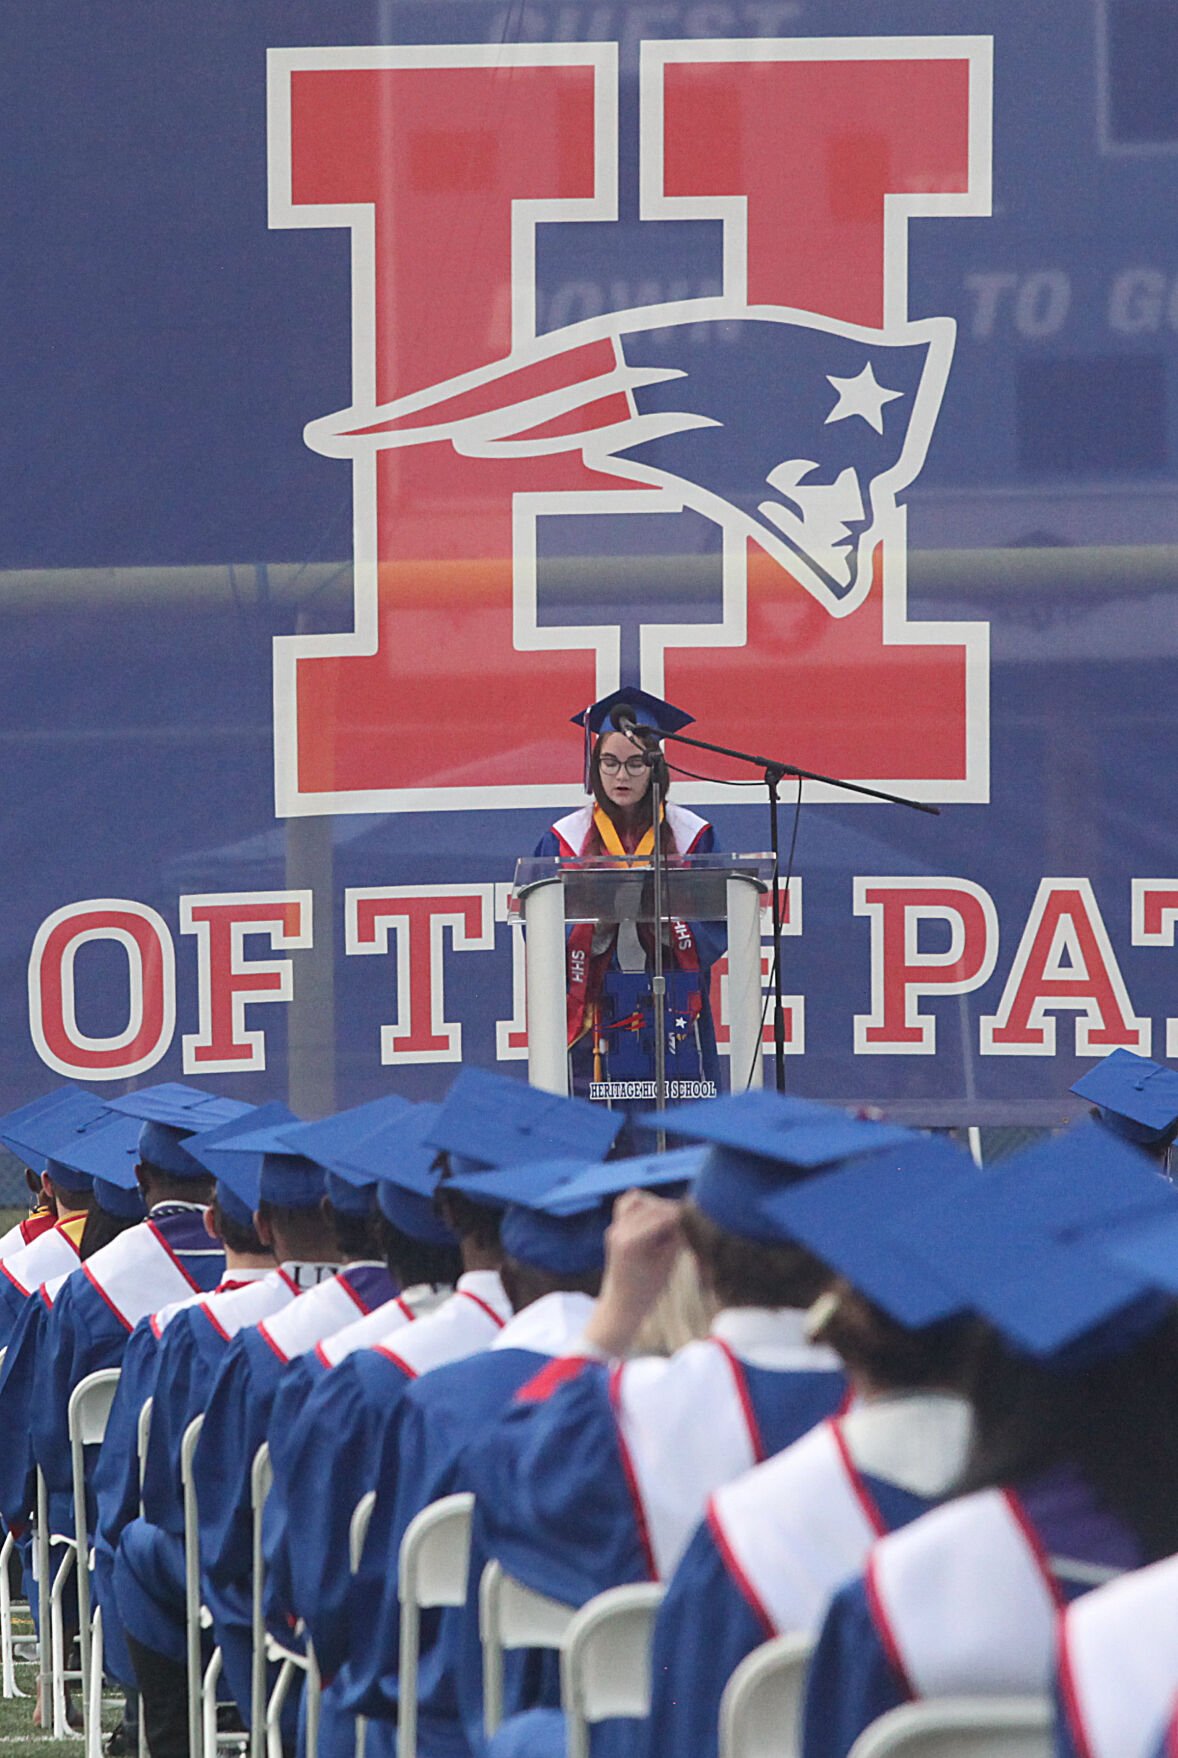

306,299,955,617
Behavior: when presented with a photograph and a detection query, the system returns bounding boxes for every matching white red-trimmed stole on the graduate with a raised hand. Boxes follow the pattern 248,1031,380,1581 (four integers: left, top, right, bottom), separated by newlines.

610,1306,840,1580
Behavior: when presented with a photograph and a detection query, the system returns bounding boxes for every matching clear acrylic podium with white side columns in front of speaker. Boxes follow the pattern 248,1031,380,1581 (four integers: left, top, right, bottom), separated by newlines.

512,854,774,1093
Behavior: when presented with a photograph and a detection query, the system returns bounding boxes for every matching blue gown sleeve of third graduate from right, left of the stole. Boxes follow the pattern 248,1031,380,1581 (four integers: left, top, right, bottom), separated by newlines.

645,1521,775,1758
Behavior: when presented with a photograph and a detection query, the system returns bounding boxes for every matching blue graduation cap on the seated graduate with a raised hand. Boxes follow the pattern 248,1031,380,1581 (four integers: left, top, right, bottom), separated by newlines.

654,1092,925,1245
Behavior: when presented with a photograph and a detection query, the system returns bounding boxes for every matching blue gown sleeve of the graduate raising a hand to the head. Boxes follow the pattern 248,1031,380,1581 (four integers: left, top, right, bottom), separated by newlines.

469,1362,651,1605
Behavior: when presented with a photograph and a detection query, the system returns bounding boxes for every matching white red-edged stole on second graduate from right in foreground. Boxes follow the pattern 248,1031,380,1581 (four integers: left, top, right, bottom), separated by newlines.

867,1489,1083,1696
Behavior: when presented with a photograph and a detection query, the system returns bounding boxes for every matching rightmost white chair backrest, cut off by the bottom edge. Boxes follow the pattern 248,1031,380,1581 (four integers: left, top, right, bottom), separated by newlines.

851,1696,1055,1758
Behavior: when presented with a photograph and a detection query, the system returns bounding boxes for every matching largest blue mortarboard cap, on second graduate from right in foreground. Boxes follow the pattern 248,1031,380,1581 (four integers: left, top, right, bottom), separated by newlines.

896,1123,1178,1366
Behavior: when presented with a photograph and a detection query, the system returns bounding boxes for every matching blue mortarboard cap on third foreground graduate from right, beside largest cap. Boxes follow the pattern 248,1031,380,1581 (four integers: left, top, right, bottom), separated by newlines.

761,1136,983,1329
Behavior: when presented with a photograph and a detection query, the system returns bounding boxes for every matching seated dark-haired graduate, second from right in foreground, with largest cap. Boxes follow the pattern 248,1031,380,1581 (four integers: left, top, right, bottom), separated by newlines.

804,1123,1178,1758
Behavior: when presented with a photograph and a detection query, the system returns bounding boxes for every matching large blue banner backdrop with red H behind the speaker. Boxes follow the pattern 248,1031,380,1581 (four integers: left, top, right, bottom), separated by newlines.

0,0,1178,1123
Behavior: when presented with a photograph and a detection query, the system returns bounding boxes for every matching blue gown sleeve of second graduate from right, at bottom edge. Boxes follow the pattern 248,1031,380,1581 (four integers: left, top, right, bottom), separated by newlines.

802,1577,907,1758
